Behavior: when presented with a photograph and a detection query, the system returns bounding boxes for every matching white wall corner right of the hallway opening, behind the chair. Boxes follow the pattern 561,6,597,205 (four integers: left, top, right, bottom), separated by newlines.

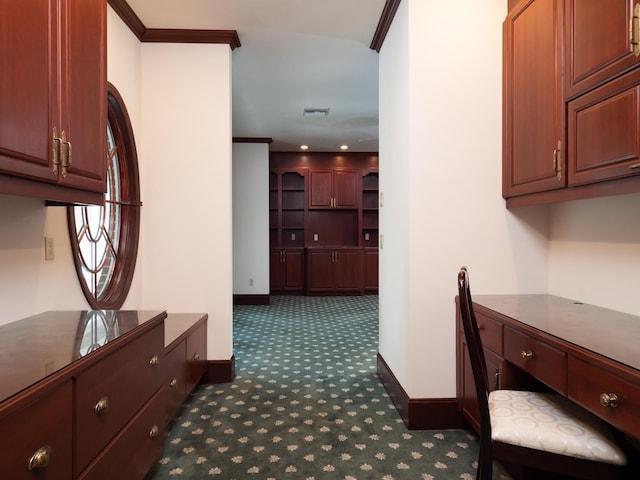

380,0,548,398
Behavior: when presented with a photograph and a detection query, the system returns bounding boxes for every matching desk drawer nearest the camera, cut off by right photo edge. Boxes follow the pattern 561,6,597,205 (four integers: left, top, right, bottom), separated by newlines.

568,357,640,438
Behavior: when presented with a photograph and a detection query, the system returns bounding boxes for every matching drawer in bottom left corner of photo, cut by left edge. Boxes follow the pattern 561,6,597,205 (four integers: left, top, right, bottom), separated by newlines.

0,381,72,480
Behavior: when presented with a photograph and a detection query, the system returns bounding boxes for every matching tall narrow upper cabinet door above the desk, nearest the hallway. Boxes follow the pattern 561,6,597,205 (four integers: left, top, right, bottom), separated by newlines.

502,0,566,198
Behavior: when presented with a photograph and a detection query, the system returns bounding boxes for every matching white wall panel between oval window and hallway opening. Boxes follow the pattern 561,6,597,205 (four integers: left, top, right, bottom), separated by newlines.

138,43,232,360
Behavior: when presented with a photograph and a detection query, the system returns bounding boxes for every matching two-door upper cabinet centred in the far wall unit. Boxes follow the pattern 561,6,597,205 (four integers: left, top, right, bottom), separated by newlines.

309,168,359,209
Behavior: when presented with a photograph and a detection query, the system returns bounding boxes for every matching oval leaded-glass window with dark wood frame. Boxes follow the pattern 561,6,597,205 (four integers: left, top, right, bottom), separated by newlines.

67,84,141,310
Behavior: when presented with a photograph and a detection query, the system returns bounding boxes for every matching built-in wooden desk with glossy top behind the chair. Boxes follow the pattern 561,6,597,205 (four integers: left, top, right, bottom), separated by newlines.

456,295,640,439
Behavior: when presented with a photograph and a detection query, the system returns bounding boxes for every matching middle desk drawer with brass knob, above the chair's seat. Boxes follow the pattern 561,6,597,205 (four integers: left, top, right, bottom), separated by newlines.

504,326,567,395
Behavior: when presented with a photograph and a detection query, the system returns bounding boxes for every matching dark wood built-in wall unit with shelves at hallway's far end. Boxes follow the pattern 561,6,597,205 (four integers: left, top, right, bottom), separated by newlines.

269,152,379,295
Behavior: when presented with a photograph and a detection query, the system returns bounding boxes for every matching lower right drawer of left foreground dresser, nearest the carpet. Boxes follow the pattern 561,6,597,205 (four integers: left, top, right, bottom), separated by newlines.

79,387,165,480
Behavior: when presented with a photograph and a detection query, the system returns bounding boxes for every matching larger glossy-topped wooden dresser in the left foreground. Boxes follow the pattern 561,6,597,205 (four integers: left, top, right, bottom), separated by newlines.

0,311,167,480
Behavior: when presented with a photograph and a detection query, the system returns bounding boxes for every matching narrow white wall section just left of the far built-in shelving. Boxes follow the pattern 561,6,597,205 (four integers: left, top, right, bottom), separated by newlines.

232,143,269,295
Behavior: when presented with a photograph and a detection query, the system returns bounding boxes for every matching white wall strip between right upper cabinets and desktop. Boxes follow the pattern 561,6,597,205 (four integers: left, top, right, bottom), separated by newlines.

549,193,640,315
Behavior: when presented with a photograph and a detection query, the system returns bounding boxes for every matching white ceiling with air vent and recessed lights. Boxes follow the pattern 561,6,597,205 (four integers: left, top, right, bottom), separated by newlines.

128,0,385,152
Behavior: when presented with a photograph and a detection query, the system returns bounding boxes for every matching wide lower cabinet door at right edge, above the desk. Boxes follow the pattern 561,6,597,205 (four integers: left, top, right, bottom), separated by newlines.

568,69,640,185
